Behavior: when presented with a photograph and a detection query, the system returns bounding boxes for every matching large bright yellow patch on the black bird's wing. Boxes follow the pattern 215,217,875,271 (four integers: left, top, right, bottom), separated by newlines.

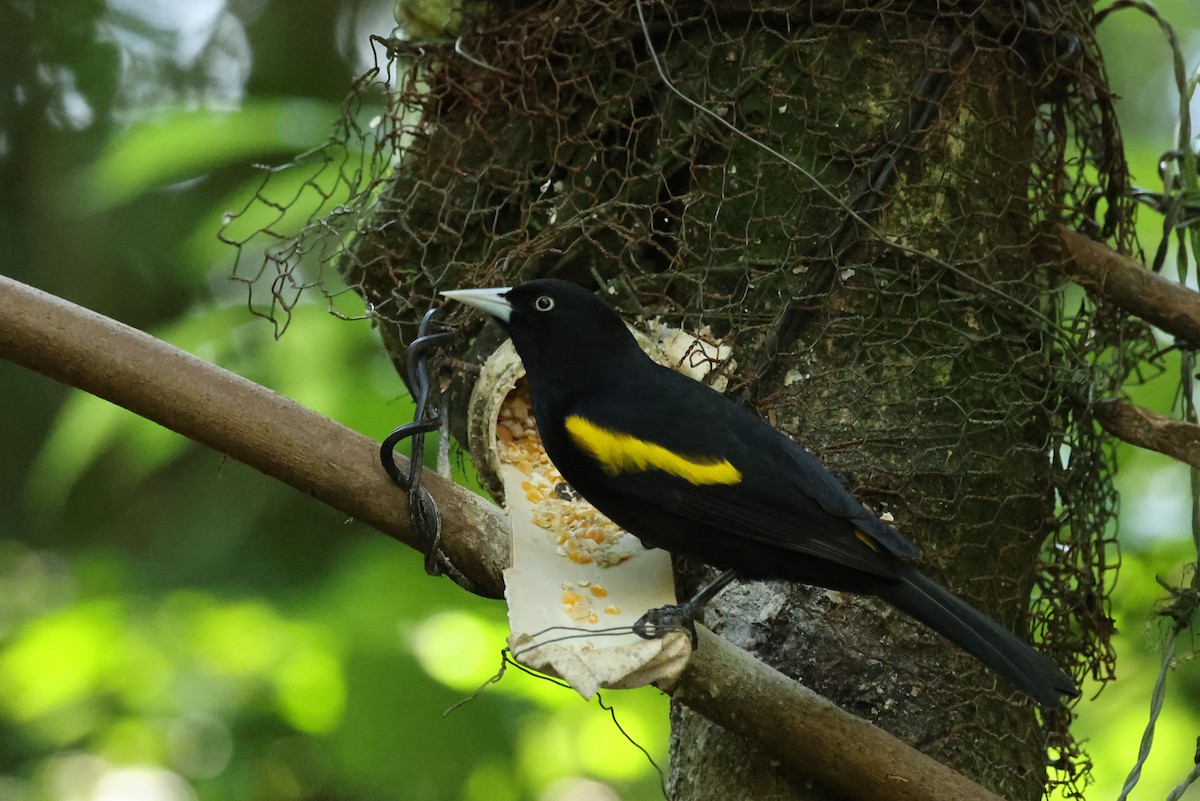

566,415,742,484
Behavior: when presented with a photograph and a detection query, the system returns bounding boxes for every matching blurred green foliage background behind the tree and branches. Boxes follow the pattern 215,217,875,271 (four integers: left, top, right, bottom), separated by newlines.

0,0,1200,801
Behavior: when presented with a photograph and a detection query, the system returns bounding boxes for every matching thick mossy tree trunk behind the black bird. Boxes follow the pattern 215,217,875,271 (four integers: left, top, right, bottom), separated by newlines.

348,0,1089,801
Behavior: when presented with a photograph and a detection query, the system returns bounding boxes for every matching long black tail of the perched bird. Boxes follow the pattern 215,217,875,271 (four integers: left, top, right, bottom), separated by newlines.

880,570,1079,706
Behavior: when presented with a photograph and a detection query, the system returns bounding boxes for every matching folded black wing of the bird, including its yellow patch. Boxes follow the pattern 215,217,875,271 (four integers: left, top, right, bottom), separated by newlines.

565,367,917,578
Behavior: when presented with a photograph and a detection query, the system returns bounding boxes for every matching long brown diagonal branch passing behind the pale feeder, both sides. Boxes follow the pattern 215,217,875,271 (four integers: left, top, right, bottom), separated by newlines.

0,276,1002,801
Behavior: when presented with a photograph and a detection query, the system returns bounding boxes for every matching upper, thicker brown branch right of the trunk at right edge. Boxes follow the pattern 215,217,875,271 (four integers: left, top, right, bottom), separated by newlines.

1052,225,1200,348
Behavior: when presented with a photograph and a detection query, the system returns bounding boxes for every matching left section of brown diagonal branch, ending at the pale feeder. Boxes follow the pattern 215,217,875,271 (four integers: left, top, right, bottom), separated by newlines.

0,276,509,597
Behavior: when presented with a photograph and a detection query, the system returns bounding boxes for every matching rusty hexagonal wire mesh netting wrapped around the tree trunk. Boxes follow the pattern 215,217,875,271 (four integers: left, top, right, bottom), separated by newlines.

226,0,1154,794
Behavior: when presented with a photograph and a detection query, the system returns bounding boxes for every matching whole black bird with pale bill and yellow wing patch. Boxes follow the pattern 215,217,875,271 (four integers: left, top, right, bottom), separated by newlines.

442,279,1079,705
